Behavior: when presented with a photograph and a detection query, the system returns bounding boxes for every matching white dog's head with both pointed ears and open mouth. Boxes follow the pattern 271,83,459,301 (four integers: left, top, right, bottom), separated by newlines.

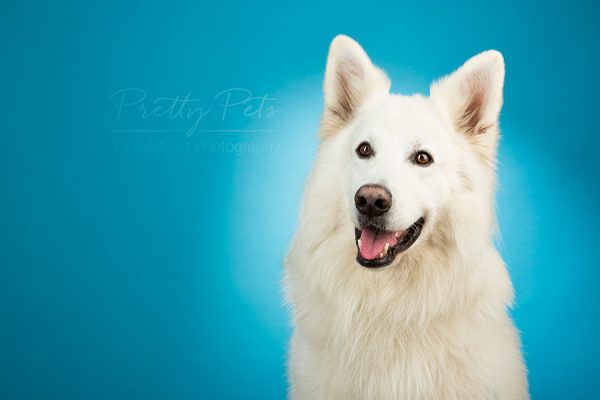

320,36,504,267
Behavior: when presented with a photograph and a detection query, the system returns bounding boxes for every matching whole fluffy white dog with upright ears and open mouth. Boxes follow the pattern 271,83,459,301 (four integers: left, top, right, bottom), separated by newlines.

285,36,529,400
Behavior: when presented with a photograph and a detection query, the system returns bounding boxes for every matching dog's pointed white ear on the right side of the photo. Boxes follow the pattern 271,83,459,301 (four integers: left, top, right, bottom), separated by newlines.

430,50,504,143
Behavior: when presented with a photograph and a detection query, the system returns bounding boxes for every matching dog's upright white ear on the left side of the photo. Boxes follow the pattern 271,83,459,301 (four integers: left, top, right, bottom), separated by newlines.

320,35,390,139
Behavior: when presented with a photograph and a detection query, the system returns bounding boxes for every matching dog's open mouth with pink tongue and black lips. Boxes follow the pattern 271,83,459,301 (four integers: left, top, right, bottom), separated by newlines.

355,217,425,268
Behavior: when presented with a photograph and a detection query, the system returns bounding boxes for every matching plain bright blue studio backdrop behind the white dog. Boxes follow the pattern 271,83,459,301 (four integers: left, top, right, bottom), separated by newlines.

0,0,600,399
